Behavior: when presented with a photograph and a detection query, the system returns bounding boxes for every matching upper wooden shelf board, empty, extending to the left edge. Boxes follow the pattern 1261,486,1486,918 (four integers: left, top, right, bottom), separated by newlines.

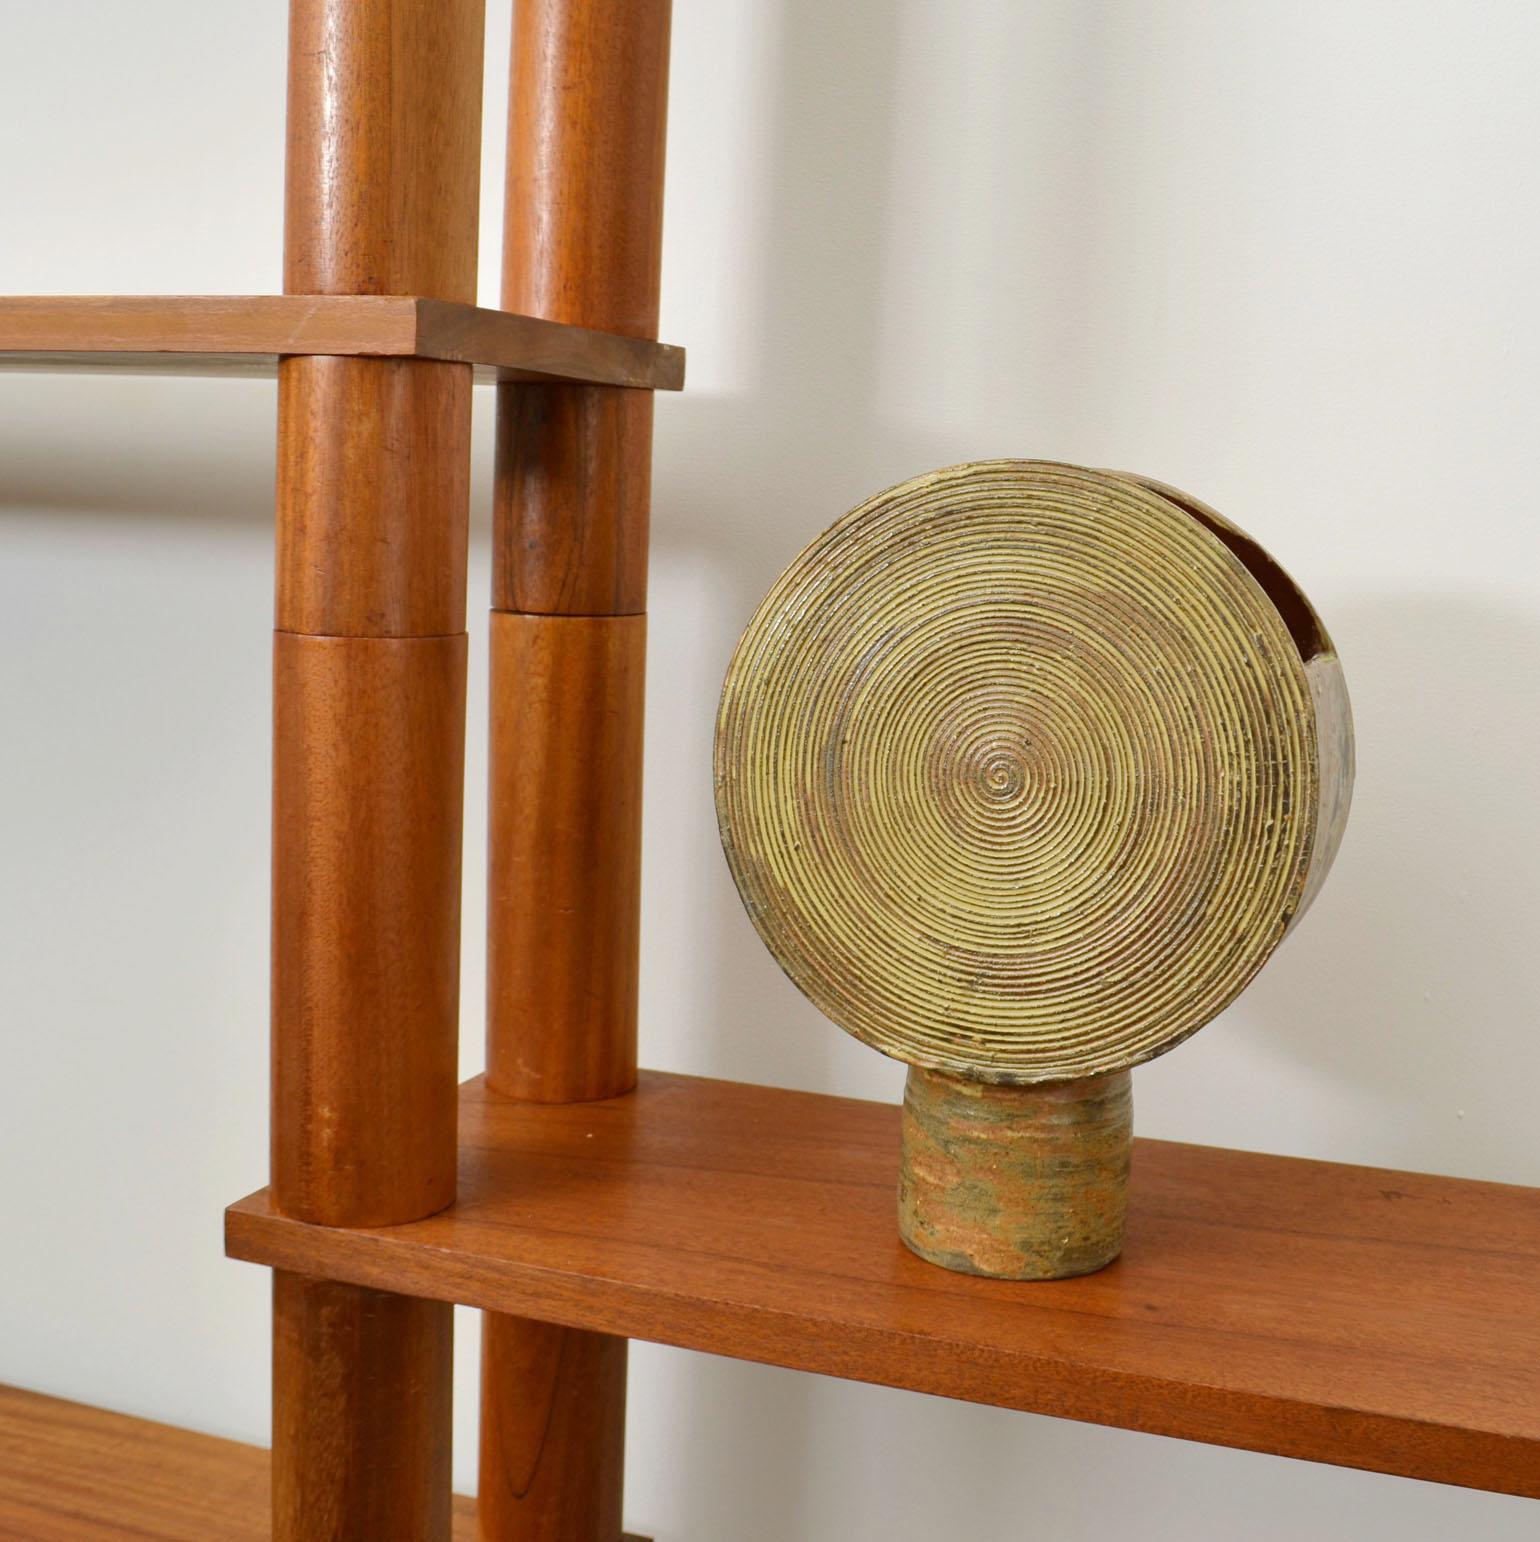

0,295,684,390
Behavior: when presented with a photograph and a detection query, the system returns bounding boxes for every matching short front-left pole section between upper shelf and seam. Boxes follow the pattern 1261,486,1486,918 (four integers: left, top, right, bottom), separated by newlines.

276,358,470,637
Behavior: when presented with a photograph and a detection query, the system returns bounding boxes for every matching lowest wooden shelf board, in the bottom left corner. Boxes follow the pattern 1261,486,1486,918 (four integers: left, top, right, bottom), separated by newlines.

0,1386,643,1542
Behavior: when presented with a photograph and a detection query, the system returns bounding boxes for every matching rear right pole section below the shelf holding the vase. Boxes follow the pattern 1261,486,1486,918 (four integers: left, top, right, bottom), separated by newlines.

476,1312,626,1542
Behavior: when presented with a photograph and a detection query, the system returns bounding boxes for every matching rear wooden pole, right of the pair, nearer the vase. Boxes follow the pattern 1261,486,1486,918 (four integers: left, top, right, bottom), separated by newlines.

478,0,669,1542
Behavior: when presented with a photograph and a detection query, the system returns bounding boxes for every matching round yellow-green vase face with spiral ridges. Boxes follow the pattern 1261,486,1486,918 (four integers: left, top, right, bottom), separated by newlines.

715,461,1318,1084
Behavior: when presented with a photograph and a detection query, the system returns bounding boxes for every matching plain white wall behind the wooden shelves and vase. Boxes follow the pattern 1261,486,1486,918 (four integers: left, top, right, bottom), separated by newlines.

0,0,1540,1542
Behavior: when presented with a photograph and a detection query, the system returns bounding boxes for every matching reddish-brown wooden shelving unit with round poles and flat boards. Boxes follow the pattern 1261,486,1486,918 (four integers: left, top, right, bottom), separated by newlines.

0,0,1540,1542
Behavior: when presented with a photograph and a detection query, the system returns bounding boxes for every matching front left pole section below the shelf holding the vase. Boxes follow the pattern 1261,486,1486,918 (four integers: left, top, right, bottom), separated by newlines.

273,1269,455,1542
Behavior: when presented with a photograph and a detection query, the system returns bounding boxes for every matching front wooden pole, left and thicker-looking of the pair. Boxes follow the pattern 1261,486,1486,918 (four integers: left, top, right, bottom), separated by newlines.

271,0,484,1542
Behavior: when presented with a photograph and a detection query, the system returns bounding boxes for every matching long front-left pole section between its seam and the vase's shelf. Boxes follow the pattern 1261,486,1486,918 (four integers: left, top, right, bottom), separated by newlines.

273,632,466,1226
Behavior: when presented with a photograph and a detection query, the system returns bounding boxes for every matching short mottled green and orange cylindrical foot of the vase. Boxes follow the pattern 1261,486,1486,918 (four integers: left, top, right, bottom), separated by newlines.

899,1066,1133,1280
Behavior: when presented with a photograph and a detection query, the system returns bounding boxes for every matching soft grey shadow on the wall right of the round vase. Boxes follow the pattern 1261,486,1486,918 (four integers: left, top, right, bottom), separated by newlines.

1242,595,1540,1184
